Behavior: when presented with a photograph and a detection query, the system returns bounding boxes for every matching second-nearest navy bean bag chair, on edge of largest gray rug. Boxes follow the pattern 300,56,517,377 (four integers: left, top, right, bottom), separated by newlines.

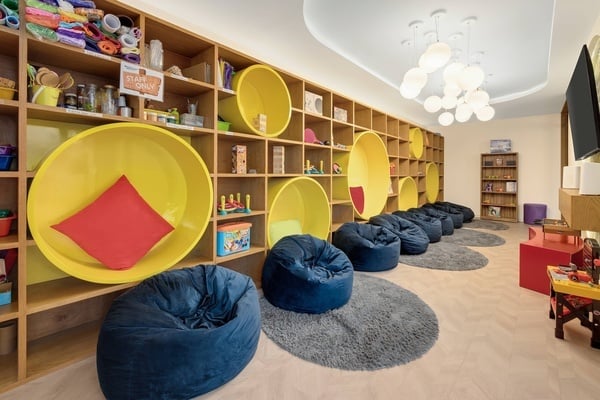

262,235,354,314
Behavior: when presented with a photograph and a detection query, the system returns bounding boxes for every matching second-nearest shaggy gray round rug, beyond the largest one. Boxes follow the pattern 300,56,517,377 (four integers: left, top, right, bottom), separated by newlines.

400,241,488,271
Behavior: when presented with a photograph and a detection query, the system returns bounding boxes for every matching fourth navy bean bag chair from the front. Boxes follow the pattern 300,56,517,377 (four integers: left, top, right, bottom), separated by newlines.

369,214,429,254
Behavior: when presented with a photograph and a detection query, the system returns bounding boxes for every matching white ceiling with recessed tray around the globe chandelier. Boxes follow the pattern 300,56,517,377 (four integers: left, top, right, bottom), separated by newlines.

121,0,600,127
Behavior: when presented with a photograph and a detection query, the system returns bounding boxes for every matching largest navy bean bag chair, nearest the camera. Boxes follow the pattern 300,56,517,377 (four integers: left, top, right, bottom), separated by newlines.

96,265,261,400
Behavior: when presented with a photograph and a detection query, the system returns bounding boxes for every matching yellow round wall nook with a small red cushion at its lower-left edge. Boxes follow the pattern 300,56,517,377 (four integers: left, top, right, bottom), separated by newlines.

348,131,390,220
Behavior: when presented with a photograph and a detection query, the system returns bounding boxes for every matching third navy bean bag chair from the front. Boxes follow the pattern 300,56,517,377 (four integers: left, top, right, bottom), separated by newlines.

332,222,400,272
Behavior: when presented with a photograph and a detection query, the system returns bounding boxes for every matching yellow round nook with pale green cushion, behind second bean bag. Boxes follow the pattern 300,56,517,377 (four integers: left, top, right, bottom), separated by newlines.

267,176,331,247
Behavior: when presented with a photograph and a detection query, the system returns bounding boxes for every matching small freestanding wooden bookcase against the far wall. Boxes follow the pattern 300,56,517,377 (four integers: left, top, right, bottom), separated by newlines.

479,153,519,222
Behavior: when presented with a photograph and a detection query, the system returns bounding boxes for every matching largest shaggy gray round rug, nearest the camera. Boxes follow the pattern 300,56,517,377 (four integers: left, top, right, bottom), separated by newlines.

260,272,439,371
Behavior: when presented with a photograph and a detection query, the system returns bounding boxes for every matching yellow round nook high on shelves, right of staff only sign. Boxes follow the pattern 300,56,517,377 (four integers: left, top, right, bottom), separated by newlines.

219,64,292,137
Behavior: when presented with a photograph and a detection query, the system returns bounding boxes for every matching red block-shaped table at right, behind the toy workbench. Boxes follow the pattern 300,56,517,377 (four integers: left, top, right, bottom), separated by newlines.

519,226,583,295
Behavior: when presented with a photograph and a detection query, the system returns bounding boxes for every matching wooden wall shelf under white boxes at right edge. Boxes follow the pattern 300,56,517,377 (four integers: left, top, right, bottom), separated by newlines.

558,188,600,232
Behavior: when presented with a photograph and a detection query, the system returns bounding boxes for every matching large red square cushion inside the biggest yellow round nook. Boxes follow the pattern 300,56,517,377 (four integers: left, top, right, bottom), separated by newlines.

52,175,174,269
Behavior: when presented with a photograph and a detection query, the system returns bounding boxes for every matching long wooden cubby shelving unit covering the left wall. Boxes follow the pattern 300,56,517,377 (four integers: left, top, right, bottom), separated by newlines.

0,0,442,392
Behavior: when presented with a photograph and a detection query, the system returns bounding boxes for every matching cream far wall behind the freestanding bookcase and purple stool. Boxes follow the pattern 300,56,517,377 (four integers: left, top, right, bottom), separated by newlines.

437,114,561,221
